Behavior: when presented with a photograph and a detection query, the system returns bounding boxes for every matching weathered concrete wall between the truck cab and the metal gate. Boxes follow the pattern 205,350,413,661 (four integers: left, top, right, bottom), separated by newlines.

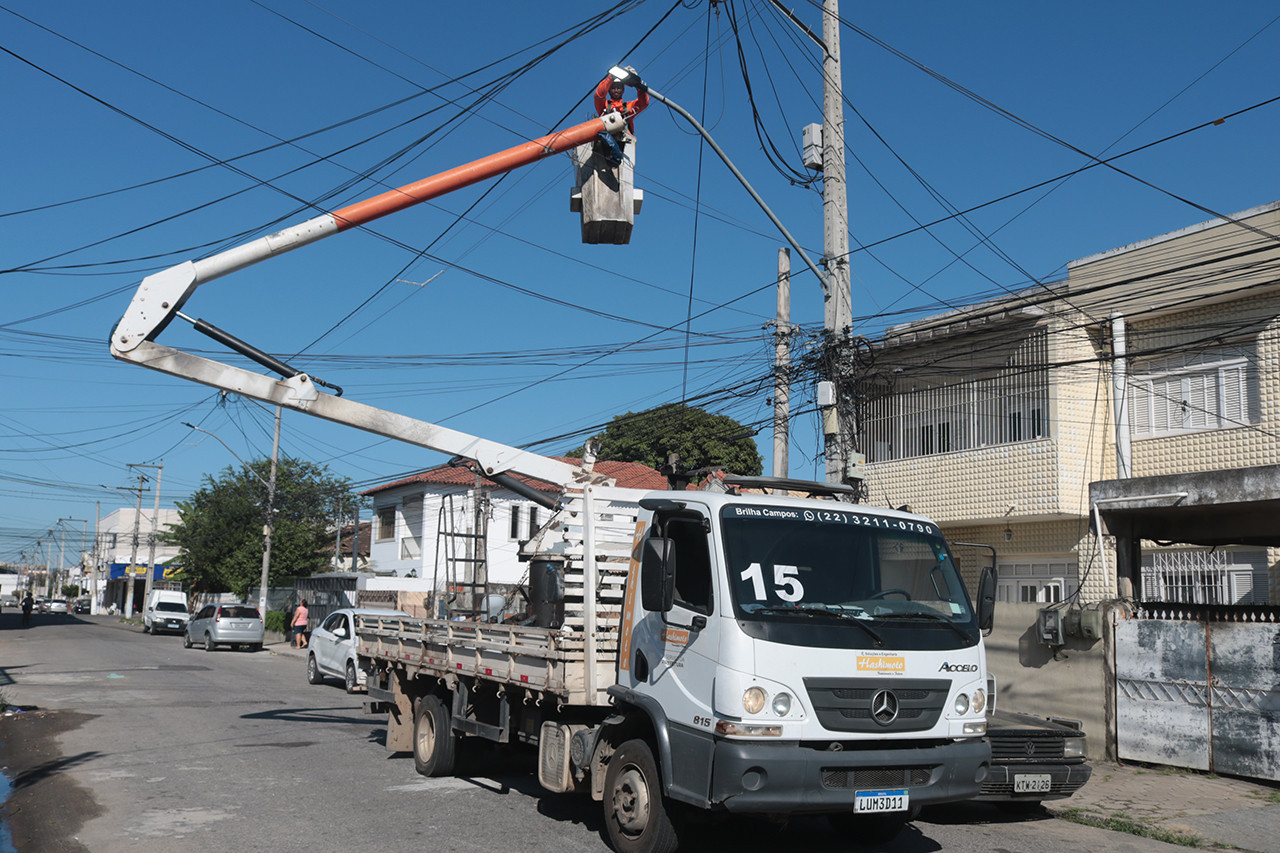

986,602,1111,757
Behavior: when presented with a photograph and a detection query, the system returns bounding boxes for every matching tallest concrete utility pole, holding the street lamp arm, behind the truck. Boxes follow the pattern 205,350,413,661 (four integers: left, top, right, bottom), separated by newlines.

822,0,854,483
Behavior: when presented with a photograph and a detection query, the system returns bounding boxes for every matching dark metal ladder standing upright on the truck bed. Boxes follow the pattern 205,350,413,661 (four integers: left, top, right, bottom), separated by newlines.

431,488,489,621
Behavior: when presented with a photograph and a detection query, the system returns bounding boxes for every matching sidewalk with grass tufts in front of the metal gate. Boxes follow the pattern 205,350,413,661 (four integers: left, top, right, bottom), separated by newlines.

1044,760,1280,853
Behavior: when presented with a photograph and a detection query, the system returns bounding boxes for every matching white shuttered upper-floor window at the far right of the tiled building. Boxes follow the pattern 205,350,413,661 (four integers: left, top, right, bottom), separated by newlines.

1129,347,1260,438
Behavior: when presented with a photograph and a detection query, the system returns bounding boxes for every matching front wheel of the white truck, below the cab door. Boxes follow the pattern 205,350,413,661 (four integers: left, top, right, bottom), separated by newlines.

604,740,680,853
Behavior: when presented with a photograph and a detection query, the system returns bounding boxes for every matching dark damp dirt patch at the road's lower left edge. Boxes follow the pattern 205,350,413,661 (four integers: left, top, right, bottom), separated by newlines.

0,711,102,853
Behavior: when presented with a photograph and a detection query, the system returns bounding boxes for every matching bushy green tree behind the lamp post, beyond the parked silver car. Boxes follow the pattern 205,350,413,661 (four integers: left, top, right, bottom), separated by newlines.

165,459,360,596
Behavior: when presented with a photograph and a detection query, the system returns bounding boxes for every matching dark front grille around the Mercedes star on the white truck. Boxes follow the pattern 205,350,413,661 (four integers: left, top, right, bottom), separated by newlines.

804,678,951,734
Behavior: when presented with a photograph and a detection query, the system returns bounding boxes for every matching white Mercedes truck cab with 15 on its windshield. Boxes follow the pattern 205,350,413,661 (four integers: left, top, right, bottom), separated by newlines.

609,492,989,829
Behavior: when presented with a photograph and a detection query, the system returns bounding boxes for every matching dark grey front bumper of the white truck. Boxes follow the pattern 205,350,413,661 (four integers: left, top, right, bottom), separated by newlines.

710,739,991,815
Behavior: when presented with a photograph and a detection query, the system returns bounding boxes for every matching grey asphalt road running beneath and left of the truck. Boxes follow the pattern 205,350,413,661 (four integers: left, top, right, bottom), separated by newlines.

0,612,1181,853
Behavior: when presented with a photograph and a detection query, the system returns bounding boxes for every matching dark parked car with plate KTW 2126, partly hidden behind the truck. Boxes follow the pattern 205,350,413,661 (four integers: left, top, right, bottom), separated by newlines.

975,711,1093,811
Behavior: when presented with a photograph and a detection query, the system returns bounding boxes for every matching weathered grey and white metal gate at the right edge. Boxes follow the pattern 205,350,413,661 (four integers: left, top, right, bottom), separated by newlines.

1115,606,1280,780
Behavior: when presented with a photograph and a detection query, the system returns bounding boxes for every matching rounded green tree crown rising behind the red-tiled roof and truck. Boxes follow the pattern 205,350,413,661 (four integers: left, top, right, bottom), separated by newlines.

570,403,764,476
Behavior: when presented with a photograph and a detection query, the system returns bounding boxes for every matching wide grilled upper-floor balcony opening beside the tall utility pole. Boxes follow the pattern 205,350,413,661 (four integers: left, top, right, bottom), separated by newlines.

861,328,1050,462
